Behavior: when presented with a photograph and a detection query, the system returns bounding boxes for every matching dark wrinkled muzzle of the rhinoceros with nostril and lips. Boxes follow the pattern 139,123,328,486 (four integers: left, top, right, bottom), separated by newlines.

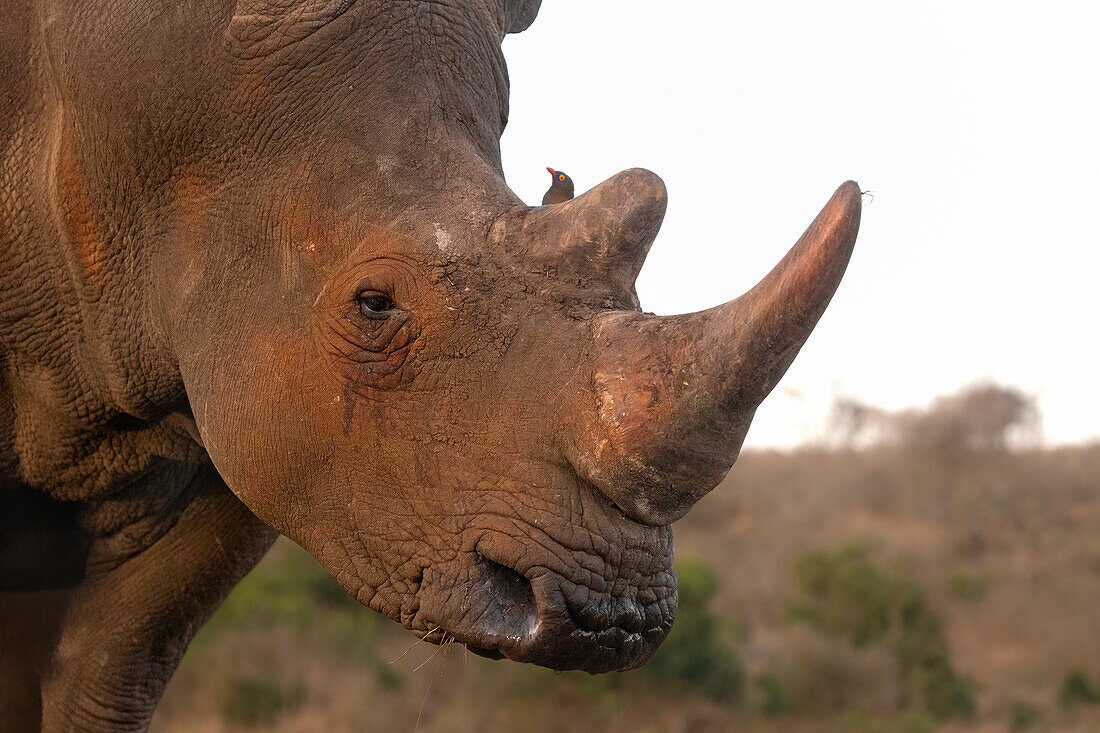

413,528,677,672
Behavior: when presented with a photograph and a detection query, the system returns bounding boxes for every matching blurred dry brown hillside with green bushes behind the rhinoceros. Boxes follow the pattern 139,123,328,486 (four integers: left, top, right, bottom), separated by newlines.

152,384,1100,733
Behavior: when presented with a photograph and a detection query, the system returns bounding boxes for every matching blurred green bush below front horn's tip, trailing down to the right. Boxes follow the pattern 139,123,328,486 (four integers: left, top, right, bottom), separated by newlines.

789,544,974,721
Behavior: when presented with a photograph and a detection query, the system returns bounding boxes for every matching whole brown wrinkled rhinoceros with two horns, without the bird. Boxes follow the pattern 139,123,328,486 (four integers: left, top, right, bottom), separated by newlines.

0,0,860,731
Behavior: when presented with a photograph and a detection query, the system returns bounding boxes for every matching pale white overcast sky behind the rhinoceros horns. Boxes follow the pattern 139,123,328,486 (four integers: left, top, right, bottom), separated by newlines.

503,0,1100,446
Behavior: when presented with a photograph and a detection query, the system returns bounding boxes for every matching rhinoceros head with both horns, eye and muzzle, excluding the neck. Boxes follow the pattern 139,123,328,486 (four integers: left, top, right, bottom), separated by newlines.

163,0,859,671
